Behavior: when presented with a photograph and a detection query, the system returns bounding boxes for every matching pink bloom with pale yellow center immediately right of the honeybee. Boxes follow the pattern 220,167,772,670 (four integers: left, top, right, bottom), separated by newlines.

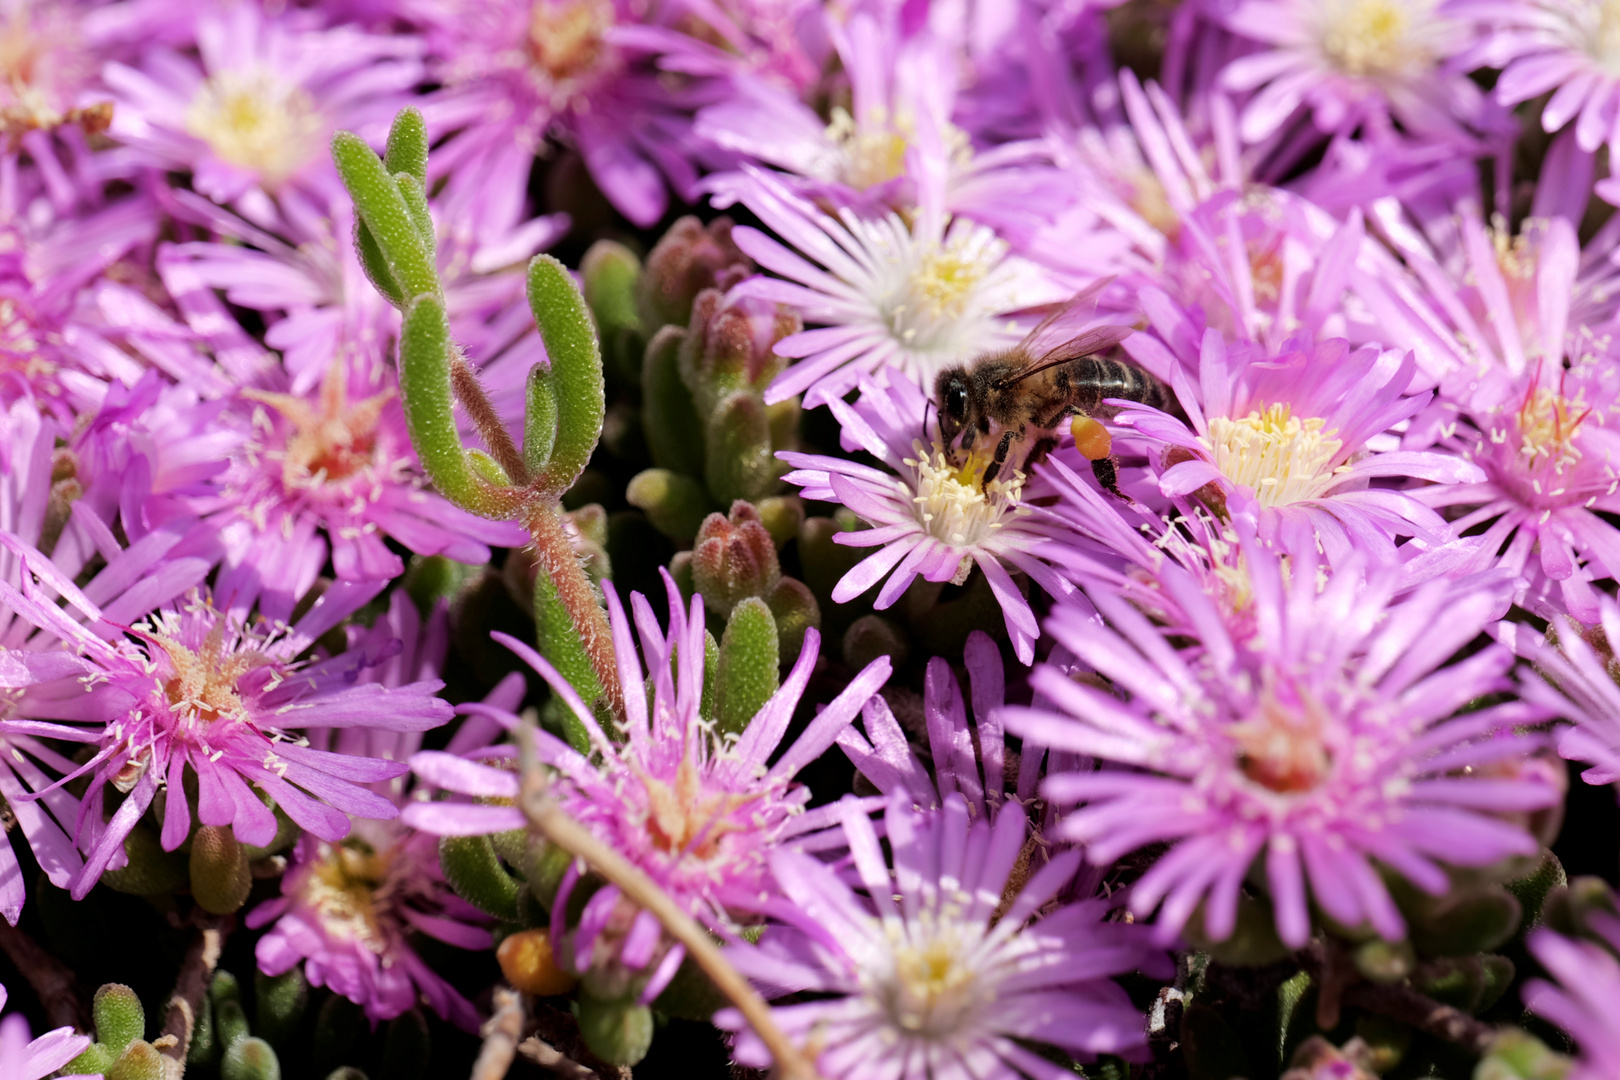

1118,329,1482,563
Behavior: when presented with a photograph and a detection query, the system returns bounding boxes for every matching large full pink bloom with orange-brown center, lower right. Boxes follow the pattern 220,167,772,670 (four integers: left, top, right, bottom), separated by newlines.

1003,560,1562,949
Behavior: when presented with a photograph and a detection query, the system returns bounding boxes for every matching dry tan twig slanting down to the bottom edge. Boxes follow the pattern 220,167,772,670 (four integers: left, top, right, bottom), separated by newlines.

518,725,818,1080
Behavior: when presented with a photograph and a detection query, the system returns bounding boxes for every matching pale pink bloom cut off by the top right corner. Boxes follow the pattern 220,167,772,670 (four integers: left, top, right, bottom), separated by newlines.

1450,0,1620,202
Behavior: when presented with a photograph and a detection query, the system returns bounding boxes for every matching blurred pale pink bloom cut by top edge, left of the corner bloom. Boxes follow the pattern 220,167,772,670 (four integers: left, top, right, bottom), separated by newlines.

1220,0,1486,142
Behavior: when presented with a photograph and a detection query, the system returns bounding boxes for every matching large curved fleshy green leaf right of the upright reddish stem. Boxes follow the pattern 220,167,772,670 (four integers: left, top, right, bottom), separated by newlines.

528,254,606,495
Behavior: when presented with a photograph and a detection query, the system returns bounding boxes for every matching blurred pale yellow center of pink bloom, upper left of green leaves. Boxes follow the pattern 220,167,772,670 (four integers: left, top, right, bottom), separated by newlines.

186,68,326,188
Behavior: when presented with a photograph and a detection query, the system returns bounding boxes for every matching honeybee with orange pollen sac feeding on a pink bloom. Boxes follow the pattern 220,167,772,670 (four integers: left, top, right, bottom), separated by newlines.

933,282,1179,499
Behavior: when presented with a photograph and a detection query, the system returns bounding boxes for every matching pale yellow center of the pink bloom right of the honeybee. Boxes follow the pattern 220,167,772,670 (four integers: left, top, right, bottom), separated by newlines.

1199,405,1348,507
